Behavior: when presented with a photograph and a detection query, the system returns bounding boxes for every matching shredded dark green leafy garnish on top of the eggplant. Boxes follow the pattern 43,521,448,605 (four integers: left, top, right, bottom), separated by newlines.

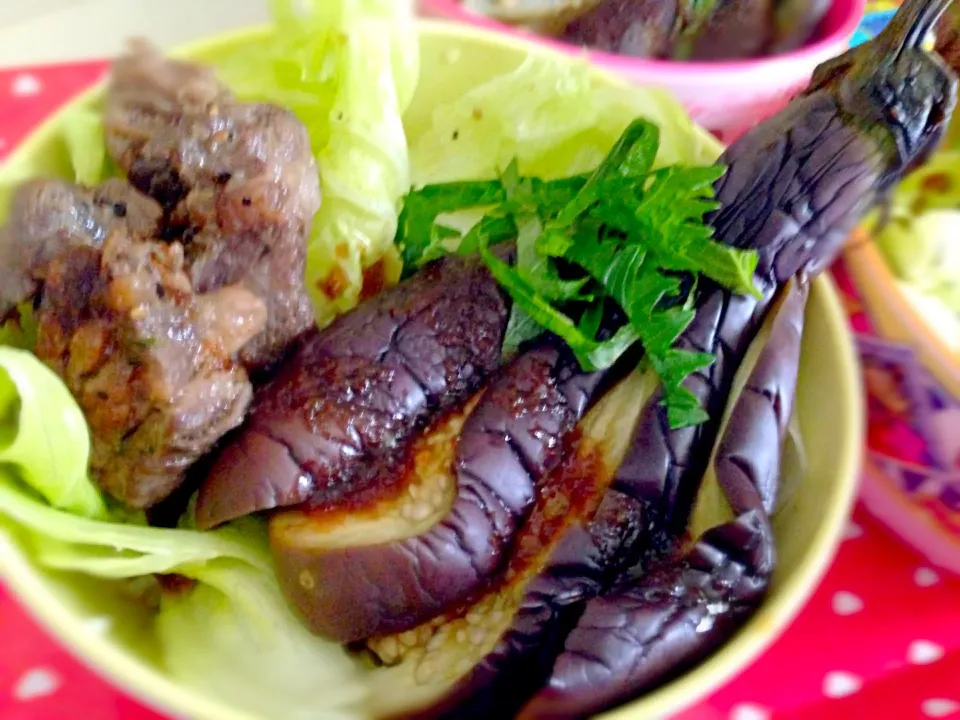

397,120,759,428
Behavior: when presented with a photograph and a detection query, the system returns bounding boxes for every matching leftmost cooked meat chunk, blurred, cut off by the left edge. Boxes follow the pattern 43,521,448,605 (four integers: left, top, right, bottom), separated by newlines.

0,180,162,315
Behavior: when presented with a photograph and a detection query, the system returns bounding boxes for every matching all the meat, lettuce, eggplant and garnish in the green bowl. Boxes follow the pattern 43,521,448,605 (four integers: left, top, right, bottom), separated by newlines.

0,2,944,717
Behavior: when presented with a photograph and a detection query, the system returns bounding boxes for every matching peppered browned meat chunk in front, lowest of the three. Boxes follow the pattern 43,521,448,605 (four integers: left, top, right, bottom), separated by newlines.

37,229,267,508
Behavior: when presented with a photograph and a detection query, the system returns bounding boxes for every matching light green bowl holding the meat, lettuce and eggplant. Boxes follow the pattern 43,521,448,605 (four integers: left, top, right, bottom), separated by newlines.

0,16,863,720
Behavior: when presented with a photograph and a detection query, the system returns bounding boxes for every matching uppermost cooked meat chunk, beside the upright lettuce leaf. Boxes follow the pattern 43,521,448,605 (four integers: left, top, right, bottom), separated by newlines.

105,42,320,368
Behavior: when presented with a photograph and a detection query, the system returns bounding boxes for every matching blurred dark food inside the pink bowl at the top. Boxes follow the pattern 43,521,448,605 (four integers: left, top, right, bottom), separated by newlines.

450,0,830,61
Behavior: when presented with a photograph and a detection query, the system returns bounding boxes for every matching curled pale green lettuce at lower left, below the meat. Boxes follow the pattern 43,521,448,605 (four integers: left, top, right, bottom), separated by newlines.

0,347,366,720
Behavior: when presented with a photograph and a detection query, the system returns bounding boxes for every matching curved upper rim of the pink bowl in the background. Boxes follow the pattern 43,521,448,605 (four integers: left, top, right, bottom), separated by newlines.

419,0,867,80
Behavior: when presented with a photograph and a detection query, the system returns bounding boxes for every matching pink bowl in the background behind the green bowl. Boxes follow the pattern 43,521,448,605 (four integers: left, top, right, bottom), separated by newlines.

420,0,866,142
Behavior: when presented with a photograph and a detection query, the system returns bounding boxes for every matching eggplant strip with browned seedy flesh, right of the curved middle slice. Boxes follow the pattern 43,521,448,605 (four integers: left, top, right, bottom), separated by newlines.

368,371,655,718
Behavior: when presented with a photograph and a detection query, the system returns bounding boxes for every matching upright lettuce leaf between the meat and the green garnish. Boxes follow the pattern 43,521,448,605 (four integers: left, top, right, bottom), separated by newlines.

217,0,419,326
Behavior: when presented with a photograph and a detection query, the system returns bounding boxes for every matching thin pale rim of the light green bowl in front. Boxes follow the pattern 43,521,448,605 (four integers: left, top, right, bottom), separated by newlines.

0,18,865,720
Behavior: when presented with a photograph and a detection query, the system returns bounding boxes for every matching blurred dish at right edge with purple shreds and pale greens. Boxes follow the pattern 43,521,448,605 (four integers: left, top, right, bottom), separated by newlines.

835,8,960,572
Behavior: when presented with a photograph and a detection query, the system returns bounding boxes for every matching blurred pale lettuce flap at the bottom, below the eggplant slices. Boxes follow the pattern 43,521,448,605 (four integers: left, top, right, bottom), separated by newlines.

157,560,367,720
